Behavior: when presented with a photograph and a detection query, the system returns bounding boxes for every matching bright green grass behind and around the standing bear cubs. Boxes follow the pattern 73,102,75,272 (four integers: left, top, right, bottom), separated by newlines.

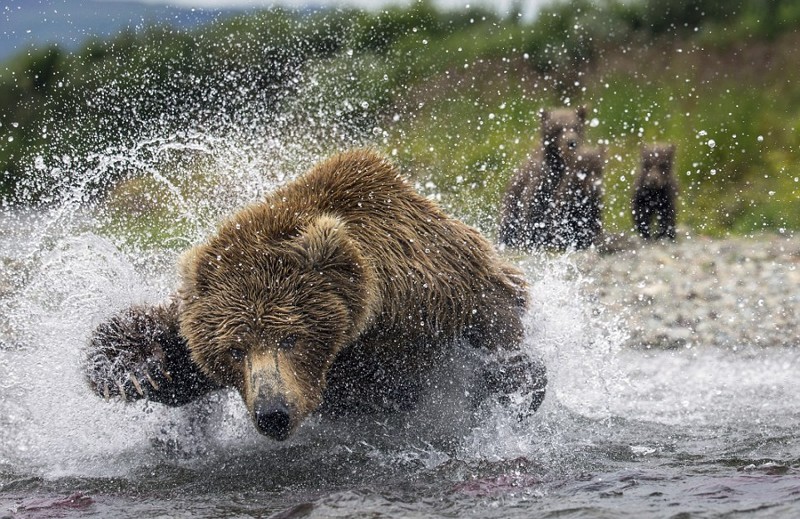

387,34,800,240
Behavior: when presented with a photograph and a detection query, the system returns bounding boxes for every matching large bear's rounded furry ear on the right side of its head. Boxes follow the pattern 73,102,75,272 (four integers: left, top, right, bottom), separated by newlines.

297,215,372,321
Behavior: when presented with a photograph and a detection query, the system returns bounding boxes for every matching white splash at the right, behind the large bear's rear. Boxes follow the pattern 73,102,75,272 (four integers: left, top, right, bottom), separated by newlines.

462,256,628,465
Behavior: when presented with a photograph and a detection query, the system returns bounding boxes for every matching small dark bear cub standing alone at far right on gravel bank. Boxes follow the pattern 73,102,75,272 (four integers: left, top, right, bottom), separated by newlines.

631,144,678,240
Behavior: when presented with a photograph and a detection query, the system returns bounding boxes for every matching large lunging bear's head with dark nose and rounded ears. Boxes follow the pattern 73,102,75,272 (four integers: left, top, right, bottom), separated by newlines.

180,213,374,440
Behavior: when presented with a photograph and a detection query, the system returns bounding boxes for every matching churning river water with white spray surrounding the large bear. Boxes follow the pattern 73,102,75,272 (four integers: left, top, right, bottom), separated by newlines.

0,139,800,518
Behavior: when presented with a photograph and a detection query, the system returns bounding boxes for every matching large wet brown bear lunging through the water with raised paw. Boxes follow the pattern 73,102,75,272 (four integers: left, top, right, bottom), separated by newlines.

87,150,546,440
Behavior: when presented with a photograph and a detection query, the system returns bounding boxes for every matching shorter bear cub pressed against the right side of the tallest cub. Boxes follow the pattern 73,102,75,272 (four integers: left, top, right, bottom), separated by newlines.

550,148,605,250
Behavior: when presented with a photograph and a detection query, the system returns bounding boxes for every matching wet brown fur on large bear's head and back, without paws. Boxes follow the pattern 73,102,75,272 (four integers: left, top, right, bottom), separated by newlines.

180,151,525,434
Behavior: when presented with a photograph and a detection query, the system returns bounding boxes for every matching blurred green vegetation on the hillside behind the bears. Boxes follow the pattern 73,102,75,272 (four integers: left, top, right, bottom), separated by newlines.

0,0,800,239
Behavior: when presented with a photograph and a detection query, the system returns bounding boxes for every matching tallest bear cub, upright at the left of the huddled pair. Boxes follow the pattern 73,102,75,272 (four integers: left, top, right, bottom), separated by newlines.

498,107,586,249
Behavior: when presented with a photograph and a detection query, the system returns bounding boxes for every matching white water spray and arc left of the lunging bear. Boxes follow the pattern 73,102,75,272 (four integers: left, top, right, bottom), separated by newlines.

0,134,330,476
